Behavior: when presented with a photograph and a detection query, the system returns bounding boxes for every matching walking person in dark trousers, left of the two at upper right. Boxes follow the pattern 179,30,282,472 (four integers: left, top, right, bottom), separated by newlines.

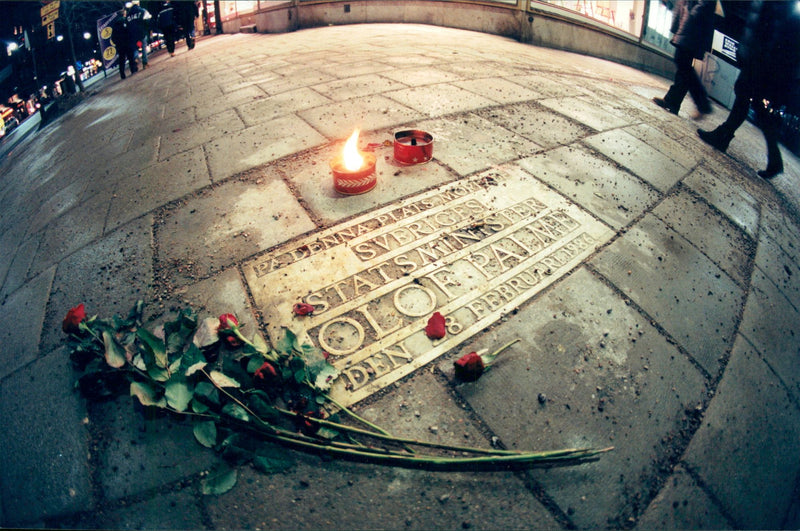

653,0,717,117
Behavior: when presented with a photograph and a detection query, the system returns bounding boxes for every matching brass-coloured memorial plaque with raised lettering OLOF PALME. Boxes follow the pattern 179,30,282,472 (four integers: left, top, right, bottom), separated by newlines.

244,165,613,405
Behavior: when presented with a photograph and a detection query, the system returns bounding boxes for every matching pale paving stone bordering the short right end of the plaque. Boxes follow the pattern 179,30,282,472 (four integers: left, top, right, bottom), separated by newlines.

518,145,659,228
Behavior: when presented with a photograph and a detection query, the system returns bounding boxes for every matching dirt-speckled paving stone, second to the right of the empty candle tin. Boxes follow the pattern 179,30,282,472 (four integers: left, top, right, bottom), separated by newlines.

476,103,588,149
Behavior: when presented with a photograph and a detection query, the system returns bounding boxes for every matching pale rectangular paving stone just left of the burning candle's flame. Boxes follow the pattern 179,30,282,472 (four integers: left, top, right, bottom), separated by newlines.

206,115,325,182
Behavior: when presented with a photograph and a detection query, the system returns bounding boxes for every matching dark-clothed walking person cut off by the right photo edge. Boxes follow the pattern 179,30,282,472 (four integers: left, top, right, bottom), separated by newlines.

697,0,800,179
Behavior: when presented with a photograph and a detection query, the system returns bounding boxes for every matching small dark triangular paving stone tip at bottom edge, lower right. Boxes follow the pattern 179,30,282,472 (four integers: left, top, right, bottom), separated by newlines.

636,466,733,529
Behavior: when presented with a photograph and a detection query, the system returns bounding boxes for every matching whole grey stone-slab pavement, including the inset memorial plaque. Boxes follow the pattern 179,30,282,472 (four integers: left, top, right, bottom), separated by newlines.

0,25,800,529
